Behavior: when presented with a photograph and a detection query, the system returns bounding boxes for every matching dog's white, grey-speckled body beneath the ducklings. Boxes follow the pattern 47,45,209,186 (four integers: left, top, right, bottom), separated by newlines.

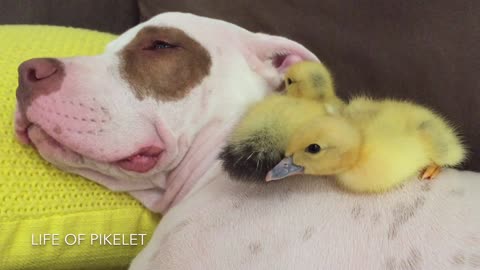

136,173,480,269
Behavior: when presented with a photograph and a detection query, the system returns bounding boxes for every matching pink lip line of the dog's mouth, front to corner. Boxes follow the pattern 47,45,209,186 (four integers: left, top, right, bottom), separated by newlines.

15,113,164,173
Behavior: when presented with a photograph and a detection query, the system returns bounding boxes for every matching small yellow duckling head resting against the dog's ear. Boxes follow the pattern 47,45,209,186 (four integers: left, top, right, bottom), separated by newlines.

285,61,336,101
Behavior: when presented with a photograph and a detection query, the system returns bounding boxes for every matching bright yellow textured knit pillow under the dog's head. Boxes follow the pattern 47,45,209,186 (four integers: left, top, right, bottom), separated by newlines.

0,25,159,270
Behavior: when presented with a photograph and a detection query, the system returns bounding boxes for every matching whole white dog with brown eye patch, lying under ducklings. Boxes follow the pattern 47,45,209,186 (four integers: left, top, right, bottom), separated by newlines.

16,13,480,270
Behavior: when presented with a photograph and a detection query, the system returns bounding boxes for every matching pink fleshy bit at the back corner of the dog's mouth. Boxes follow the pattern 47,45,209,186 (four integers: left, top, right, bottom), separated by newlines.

117,148,162,173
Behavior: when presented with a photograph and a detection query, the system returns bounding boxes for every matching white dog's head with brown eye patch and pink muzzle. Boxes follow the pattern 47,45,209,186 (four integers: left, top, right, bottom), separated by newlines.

15,13,316,211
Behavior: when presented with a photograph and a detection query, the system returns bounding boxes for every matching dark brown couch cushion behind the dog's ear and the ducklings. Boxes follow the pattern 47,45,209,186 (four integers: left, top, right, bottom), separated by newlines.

139,0,480,171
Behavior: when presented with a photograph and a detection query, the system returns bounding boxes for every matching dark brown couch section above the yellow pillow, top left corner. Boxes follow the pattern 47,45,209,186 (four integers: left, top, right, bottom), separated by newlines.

0,0,139,33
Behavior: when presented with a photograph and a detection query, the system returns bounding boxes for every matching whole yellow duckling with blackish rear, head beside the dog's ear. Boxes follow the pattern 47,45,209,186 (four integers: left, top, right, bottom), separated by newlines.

220,62,343,181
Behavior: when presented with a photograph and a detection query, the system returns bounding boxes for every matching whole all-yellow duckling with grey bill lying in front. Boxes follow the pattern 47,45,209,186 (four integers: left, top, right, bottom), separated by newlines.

266,97,466,192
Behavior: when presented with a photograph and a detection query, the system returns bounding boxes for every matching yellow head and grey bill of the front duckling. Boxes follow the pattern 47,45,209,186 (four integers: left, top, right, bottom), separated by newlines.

266,116,361,181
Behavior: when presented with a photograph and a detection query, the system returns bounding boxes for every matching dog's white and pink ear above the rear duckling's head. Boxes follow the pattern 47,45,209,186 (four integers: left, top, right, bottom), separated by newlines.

246,33,319,89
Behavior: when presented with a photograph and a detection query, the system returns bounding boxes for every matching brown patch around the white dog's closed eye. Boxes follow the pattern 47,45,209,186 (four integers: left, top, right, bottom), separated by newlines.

120,26,212,101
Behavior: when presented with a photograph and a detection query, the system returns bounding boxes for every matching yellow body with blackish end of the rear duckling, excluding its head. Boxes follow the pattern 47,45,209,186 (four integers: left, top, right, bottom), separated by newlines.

220,95,334,181
